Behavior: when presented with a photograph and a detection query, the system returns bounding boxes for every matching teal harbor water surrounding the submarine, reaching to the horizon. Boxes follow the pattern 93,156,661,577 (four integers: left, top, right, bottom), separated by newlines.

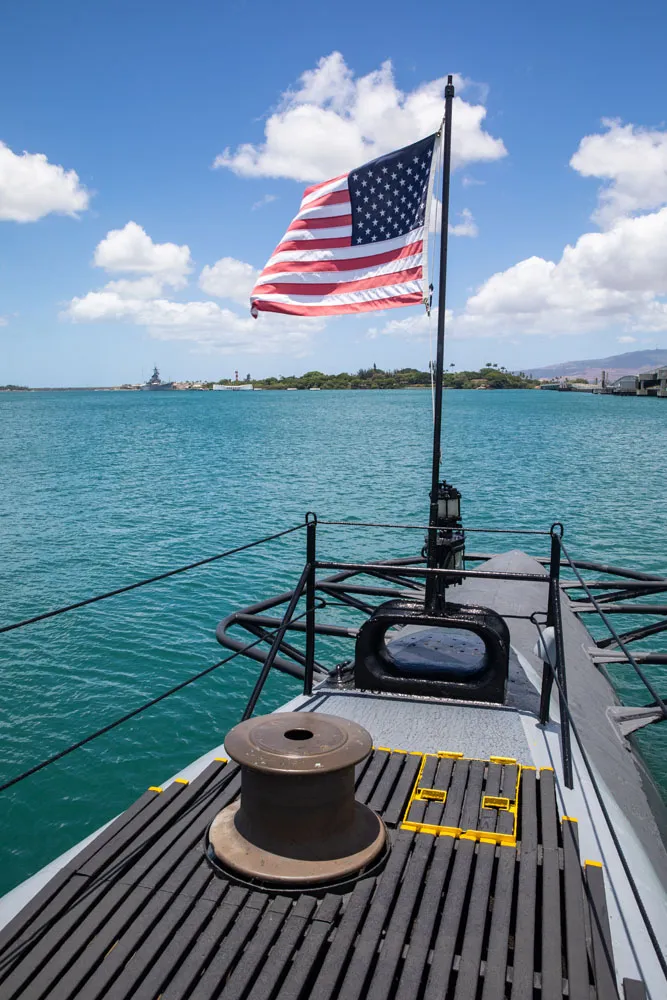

0,391,667,891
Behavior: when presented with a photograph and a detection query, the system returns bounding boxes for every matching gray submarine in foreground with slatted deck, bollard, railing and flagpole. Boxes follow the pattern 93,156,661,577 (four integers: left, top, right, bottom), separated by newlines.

0,77,667,1000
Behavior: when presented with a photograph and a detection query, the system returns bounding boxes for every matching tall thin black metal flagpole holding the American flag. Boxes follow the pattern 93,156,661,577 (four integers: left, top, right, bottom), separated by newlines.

425,76,454,610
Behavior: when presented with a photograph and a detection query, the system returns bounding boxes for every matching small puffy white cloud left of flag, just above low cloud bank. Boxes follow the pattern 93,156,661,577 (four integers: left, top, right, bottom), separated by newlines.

94,222,192,288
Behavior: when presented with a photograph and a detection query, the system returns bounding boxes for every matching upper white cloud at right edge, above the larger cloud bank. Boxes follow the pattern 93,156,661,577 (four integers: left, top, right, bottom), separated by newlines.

570,119,667,226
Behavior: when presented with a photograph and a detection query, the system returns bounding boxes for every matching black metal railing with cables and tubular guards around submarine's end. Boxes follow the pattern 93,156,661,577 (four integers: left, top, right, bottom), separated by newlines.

0,512,667,791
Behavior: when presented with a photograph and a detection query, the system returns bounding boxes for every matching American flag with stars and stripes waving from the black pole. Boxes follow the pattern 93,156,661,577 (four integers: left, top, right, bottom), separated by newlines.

250,135,437,316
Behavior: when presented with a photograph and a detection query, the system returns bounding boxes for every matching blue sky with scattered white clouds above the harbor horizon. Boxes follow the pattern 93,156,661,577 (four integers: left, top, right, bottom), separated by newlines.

0,0,667,385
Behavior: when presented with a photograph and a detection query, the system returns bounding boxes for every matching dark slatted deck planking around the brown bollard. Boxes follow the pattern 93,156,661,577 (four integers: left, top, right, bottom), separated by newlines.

0,750,632,1000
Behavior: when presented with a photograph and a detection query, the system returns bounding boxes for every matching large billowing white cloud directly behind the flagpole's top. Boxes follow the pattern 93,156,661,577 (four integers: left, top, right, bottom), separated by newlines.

213,52,507,181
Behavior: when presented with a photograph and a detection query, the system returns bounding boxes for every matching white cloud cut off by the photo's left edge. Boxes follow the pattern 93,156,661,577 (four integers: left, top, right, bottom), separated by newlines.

0,142,90,222
